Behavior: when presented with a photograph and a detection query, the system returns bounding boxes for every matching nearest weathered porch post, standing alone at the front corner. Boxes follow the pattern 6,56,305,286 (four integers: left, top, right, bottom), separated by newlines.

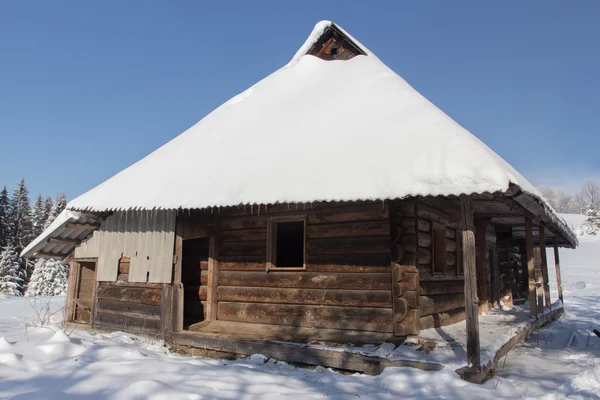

460,194,481,368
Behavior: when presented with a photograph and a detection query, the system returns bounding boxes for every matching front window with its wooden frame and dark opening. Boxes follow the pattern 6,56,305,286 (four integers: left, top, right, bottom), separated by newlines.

267,217,306,270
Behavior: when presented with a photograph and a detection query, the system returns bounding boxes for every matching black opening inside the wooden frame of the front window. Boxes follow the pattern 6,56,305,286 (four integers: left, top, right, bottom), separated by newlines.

269,220,304,268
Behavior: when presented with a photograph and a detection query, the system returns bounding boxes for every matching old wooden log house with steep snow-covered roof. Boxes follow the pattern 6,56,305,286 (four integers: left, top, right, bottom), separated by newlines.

24,22,577,378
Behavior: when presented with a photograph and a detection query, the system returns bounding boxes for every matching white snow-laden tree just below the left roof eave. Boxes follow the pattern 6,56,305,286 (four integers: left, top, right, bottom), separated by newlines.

25,258,69,296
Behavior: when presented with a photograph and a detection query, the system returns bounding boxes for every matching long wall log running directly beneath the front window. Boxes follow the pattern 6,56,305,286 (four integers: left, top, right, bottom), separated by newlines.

209,270,391,290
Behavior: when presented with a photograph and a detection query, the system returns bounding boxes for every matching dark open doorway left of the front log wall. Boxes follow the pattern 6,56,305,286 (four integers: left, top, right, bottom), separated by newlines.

181,237,210,329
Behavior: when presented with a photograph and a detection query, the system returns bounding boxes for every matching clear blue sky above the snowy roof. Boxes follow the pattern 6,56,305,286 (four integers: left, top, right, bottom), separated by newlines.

0,0,600,198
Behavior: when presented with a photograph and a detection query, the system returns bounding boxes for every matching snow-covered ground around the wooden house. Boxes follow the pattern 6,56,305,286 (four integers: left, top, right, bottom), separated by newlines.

0,237,600,399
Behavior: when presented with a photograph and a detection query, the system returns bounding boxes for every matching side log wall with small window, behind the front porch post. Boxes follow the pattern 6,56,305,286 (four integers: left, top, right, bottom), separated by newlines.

395,198,465,329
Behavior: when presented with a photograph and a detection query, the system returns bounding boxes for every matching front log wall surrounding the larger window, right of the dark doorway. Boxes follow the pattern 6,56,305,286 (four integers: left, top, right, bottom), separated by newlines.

191,202,393,333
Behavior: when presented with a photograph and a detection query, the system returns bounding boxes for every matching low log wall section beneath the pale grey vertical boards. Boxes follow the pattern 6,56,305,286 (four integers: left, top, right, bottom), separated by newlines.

93,281,163,335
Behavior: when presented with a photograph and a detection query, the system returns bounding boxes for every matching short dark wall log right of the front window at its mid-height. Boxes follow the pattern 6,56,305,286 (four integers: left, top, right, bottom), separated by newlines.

306,233,390,254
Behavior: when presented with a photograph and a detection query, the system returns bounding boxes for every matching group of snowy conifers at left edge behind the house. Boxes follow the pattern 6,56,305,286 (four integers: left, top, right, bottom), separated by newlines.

0,179,68,296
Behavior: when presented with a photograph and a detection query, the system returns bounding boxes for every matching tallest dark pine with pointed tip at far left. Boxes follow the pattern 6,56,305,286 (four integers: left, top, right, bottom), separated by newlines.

9,179,34,252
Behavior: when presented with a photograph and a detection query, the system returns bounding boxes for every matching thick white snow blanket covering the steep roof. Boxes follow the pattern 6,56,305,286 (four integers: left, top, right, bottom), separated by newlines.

62,21,568,247
